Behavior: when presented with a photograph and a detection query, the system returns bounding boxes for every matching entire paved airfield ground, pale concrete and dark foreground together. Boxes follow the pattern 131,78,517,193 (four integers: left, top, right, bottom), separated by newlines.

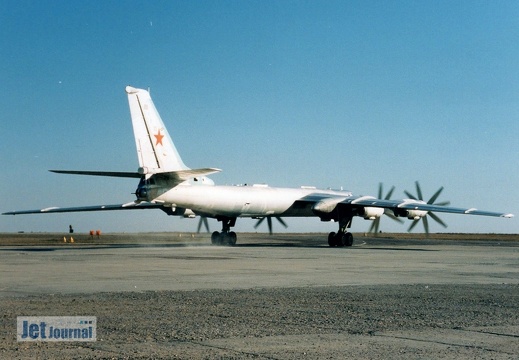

0,234,519,359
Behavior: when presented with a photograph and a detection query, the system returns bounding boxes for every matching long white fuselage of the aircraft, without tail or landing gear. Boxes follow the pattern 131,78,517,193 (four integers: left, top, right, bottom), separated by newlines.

155,182,351,217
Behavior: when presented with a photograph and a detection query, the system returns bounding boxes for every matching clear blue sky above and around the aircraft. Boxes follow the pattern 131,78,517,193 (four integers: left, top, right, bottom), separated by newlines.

0,1,519,233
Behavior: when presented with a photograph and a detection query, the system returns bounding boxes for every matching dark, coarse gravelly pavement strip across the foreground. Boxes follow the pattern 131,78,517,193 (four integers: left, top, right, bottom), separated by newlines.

0,284,519,359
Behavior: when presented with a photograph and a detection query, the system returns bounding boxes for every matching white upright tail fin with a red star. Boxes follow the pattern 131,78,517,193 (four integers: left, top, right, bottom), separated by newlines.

126,86,189,174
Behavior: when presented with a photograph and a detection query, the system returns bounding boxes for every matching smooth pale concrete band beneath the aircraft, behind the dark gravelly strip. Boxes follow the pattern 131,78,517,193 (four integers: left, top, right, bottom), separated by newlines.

0,234,519,296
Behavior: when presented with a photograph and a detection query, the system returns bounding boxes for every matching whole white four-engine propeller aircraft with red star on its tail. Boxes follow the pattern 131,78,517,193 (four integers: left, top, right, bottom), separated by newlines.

3,86,513,247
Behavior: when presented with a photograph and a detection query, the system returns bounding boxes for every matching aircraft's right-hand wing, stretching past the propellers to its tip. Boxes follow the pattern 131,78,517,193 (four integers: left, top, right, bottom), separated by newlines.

340,196,514,218
